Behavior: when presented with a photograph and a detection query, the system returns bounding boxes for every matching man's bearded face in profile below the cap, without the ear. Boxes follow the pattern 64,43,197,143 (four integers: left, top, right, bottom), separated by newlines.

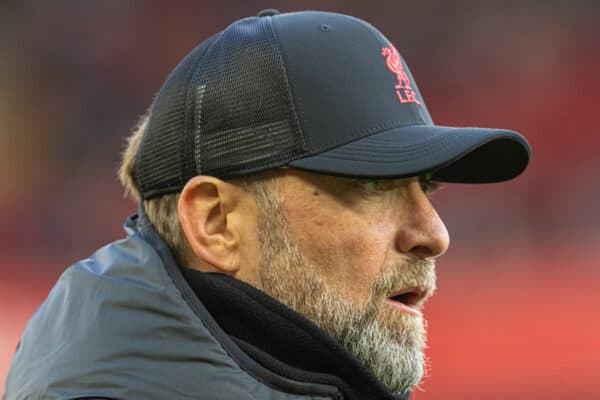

251,170,448,392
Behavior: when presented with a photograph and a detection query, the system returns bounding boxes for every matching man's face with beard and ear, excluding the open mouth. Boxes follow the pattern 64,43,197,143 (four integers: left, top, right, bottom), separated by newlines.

179,169,448,393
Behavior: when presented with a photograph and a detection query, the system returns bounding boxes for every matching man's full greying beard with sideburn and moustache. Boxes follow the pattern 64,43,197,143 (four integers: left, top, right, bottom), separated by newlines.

259,191,428,394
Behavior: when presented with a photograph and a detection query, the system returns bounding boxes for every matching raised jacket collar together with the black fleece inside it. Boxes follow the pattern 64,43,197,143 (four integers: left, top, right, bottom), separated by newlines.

130,206,410,400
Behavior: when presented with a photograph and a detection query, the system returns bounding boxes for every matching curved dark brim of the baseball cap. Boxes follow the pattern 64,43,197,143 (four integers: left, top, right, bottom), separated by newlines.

288,125,530,183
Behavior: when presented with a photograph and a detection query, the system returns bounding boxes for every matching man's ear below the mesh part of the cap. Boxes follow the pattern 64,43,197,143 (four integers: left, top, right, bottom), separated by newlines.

178,175,244,275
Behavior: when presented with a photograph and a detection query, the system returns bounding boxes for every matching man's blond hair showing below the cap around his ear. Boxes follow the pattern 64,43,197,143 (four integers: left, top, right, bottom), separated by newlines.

118,111,272,267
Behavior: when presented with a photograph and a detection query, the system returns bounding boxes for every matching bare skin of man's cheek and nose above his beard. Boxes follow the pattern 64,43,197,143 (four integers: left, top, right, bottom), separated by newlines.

270,170,449,303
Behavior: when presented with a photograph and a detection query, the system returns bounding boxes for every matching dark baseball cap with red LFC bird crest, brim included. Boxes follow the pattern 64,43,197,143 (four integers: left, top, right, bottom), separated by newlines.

134,10,530,199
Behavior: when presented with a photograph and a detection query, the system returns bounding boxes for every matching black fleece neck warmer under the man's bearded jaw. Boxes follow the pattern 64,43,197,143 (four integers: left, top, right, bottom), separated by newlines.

182,268,410,400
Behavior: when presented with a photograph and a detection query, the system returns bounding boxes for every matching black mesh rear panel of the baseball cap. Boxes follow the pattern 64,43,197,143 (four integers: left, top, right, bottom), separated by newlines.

134,18,306,199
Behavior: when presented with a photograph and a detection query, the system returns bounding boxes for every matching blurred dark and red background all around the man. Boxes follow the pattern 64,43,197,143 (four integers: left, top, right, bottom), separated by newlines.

0,0,600,400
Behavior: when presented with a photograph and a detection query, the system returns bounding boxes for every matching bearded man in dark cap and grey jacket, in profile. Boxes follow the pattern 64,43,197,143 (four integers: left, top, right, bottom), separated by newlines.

5,10,529,400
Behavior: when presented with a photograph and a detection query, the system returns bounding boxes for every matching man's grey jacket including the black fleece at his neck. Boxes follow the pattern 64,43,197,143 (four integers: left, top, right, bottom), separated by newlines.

3,213,408,400
